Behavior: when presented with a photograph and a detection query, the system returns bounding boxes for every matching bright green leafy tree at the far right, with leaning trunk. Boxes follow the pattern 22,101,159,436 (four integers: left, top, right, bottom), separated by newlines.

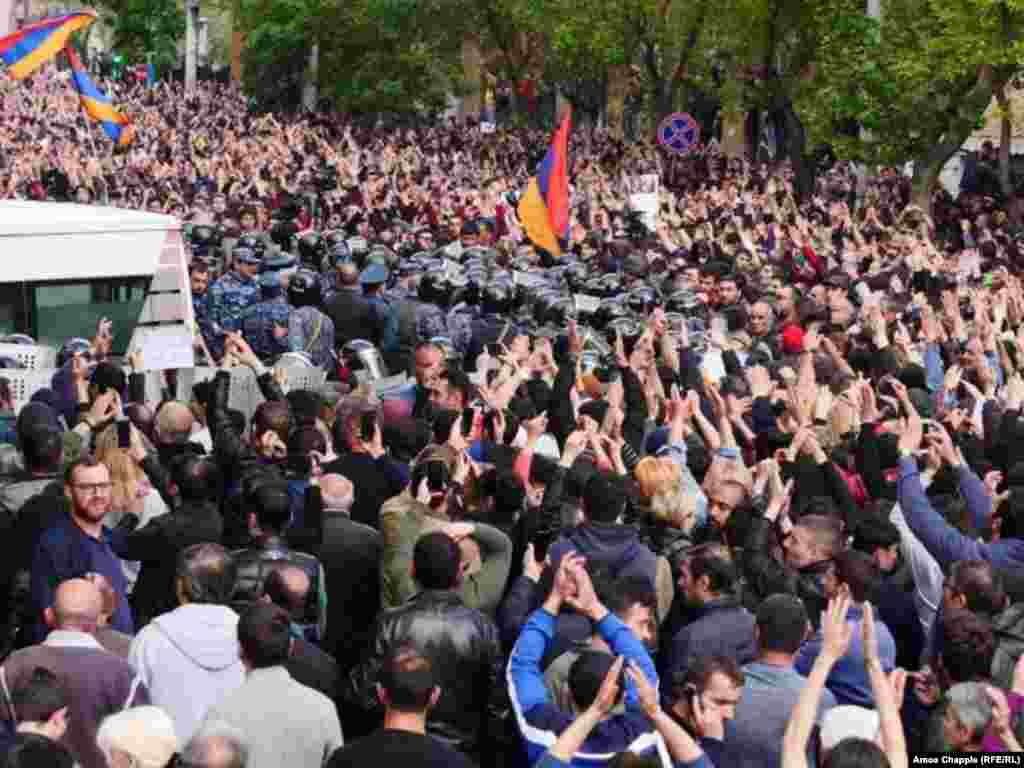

805,0,1024,211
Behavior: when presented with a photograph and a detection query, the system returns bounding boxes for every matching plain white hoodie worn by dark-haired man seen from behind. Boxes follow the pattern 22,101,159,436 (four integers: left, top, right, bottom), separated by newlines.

128,603,246,744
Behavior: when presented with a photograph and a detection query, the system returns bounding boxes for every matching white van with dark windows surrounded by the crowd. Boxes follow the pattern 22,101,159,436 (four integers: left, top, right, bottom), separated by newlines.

0,200,195,368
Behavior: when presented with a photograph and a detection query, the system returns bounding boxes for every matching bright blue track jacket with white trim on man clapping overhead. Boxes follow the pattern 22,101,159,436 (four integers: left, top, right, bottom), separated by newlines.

508,608,658,768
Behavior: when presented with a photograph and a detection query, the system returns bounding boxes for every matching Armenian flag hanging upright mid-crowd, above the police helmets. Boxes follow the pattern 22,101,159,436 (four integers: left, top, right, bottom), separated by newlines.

516,113,572,256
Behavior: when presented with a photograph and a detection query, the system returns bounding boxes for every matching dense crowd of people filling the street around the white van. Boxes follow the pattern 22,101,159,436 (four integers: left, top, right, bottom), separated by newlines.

0,70,1024,768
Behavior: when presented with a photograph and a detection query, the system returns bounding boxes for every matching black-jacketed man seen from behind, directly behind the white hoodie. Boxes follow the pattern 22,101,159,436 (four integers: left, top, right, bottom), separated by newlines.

112,453,224,627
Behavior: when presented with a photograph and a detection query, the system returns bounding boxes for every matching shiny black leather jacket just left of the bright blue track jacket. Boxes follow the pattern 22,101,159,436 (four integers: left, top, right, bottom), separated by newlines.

345,591,505,754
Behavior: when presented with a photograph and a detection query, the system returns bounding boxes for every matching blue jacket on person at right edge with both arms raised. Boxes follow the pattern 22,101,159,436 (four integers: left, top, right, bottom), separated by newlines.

898,459,1024,569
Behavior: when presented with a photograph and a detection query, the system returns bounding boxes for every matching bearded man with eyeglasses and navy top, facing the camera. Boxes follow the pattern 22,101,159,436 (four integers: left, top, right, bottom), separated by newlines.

32,457,135,641
